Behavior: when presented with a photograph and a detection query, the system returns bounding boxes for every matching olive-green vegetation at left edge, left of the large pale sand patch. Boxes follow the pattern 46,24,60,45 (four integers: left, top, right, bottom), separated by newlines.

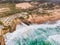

0,3,20,17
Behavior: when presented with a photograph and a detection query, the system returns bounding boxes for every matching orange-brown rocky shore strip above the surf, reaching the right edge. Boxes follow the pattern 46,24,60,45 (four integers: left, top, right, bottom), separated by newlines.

28,14,60,24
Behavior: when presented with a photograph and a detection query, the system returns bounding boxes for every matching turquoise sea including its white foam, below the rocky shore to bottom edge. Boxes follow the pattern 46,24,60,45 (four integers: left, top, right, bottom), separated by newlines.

5,20,60,45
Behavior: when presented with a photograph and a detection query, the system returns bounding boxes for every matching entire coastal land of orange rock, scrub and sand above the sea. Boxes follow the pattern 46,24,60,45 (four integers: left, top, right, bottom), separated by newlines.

0,2,60,45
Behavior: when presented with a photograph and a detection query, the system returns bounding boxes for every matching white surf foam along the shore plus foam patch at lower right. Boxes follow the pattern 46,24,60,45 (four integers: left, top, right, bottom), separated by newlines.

5,20,60,44
